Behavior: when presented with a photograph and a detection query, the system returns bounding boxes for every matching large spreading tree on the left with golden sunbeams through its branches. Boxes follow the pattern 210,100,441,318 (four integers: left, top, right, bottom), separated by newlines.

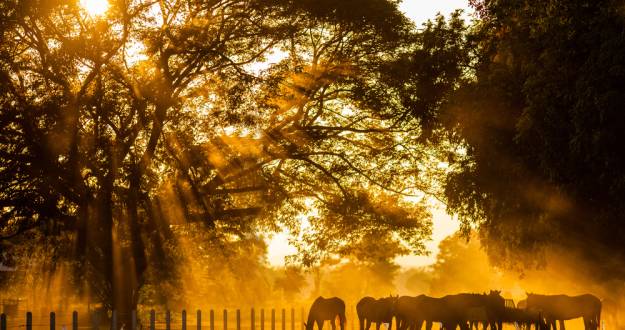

0,0,464,322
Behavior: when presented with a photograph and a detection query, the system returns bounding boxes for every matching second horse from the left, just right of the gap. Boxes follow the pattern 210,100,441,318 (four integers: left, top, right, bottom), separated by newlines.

356,296,398,330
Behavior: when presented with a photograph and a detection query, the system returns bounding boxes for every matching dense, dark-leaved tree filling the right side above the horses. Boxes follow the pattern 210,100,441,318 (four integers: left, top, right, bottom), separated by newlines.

444,0,625,279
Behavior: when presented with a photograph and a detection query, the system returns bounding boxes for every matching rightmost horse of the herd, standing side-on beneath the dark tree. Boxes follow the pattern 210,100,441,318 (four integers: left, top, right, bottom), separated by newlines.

527,293,601,330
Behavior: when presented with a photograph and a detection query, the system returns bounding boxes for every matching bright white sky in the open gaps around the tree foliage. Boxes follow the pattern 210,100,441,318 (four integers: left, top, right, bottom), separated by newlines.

268,0,470,267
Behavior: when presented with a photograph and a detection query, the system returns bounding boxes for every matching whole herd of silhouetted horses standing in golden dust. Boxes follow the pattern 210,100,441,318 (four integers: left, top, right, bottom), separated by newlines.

304,291,601,330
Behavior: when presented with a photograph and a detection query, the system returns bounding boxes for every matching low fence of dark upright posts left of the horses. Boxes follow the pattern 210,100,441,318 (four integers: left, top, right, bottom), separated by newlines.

0,308,320,330
